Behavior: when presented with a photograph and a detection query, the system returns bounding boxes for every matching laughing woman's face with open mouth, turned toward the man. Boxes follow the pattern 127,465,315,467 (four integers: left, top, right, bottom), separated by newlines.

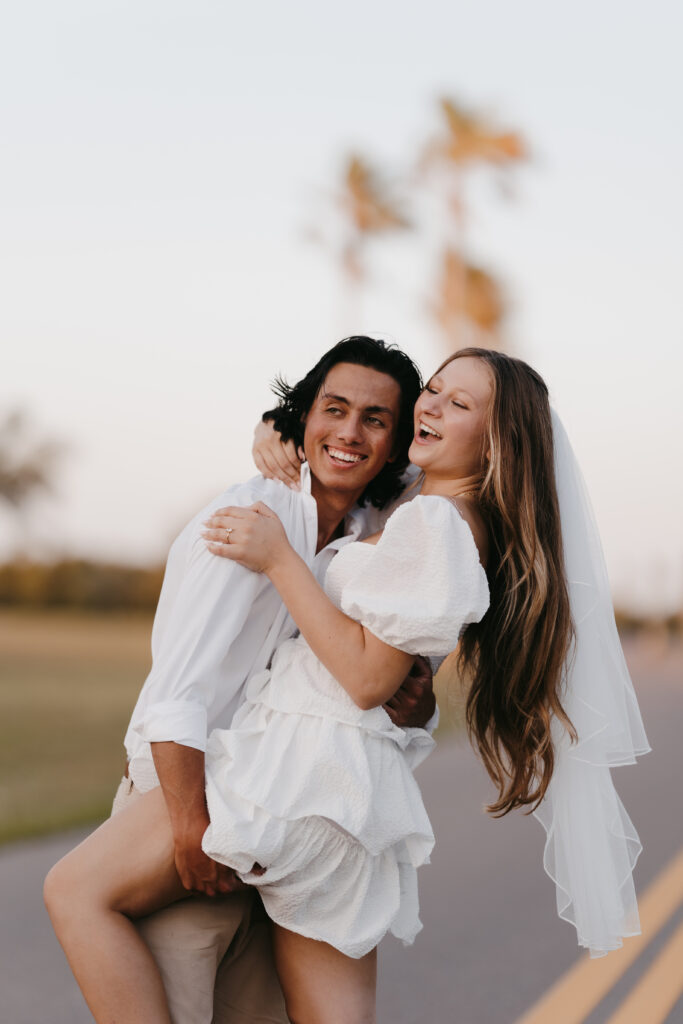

409,355,494,479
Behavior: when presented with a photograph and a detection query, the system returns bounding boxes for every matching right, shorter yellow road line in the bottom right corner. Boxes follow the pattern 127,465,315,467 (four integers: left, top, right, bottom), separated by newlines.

607,925,683,1024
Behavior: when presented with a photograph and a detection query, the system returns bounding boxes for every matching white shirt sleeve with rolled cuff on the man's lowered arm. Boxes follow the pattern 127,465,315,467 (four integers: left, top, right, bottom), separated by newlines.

126,512,268,751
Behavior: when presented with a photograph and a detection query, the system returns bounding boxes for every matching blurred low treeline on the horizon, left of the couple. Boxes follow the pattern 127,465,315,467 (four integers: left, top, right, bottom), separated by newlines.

0,558,164,611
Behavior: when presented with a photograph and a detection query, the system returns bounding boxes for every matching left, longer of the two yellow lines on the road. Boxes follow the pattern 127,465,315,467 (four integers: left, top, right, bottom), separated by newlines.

516,850,683,1024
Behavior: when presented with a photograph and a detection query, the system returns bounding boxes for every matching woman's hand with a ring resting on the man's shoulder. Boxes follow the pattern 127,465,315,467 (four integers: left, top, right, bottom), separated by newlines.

202,502,291,574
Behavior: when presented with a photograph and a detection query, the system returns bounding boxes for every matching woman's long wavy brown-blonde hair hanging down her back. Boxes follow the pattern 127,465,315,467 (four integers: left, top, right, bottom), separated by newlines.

444,348,575,817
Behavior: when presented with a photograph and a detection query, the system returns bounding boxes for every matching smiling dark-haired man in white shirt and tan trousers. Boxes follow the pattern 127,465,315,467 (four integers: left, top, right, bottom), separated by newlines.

115,337,434,1024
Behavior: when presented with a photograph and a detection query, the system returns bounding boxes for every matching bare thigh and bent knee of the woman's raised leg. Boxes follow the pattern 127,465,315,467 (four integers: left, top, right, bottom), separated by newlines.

48,787,187,918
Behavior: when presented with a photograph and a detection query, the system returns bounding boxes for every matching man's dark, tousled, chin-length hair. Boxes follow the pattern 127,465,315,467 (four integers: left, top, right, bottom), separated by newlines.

263,335,422,509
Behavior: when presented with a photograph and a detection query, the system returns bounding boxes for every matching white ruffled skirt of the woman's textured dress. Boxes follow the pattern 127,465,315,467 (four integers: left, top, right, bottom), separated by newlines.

203,640,434,957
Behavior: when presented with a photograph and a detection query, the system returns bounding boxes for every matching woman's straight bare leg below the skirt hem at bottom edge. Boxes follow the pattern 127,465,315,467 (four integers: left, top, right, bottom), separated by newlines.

273,925,377,1024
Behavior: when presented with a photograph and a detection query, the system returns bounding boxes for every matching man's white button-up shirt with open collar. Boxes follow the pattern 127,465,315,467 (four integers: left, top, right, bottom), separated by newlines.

125,464,387,790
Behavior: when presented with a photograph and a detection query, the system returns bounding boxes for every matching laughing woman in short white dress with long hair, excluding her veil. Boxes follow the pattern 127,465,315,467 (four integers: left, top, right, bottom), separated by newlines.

46,349,647,1024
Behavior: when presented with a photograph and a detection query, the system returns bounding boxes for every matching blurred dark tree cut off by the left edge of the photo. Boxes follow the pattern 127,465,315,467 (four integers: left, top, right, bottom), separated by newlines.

0,411,62,509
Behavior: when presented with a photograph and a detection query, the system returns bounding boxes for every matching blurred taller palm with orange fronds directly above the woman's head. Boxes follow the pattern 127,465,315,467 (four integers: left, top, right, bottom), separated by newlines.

420,98,526,349
